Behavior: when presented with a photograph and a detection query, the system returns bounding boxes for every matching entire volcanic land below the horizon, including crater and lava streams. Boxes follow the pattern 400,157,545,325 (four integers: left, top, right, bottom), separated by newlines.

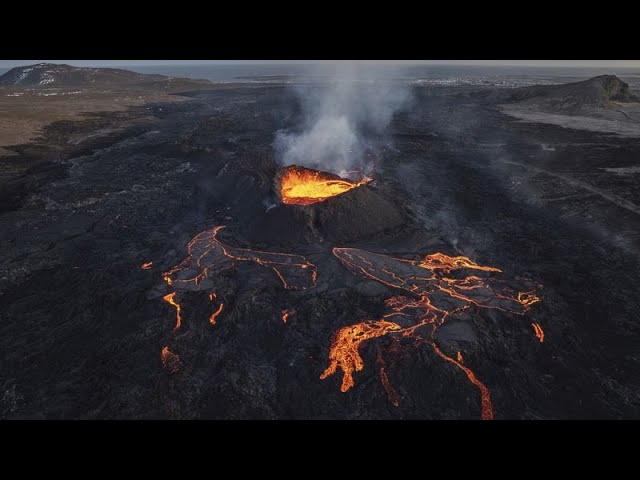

0,64,640,420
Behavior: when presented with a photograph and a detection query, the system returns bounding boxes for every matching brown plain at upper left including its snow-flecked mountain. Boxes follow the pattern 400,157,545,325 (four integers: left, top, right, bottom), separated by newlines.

0,64,211,158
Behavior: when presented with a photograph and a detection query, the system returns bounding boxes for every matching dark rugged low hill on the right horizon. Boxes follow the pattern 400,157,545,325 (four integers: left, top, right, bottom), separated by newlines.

508,75,640,112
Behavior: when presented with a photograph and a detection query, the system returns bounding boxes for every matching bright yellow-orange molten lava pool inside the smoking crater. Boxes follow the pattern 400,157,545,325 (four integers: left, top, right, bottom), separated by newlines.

280,165,371,205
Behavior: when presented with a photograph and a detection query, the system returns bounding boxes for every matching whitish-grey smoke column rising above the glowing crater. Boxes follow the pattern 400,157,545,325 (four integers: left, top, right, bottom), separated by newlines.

274,62,410,176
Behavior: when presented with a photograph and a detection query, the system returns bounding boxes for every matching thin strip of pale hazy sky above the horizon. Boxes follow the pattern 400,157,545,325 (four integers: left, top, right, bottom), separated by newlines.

0,60,640,68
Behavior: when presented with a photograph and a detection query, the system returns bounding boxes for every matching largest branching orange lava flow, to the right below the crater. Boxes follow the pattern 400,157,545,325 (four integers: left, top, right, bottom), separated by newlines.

320,248,540,419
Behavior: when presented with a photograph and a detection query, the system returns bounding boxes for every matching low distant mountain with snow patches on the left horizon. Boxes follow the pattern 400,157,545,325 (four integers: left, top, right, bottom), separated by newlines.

0,63,209,88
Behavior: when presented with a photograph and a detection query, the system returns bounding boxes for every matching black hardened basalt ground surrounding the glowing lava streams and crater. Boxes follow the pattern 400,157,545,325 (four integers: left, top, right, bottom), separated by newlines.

0,72,640,420
